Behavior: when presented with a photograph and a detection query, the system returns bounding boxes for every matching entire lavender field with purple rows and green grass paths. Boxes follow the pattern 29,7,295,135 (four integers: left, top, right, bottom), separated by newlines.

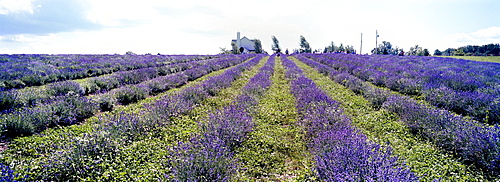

0,54,500,181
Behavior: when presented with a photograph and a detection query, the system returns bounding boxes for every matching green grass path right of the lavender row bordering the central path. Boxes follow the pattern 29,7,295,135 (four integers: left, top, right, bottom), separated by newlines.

289,57,485,181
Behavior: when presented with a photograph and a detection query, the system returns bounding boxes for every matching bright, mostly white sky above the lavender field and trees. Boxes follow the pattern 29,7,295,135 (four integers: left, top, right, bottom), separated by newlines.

0,0,500,54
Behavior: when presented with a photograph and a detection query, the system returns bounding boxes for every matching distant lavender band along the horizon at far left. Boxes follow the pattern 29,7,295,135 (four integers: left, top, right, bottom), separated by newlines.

0,54,210,91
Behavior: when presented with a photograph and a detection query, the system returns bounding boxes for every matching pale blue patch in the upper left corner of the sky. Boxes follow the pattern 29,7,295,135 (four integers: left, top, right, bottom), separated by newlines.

0,0,100,35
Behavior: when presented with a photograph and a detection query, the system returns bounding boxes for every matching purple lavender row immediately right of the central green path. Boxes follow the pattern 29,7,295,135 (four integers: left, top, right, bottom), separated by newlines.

282,57,418,181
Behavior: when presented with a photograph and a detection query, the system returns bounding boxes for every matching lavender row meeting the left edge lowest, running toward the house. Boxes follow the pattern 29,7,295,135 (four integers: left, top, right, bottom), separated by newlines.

0,55,253,137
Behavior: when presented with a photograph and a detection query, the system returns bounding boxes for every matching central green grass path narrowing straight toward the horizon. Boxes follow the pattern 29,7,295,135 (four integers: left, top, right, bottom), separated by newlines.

236,57,312,181
